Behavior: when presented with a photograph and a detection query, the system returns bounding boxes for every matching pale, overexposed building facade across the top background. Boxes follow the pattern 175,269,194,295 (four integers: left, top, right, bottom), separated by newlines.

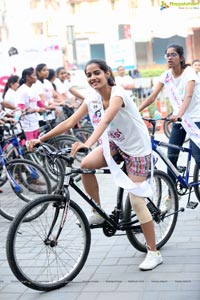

0,0,200,68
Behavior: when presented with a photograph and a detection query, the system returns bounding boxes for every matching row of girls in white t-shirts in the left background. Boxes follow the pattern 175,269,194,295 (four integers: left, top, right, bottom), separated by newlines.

1,63,84,140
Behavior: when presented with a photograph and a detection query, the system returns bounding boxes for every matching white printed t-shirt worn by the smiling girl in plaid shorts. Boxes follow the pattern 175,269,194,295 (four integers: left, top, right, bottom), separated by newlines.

84,86,152,157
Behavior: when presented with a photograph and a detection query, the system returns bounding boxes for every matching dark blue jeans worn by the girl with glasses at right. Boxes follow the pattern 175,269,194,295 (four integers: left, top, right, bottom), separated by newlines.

167,122,200,182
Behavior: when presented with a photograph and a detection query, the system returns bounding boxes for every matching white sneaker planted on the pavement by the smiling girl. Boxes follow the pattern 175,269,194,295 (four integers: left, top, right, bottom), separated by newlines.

139,251,163,271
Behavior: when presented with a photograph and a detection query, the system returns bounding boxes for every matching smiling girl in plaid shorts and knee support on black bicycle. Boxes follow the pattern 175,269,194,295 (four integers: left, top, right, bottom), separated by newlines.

29,59,162,270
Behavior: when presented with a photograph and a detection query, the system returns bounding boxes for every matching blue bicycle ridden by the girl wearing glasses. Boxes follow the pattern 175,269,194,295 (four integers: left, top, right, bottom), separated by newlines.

143,117,200,209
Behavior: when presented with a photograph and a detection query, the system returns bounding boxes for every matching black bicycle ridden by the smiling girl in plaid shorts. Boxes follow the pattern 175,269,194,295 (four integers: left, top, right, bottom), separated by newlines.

6,146,183,291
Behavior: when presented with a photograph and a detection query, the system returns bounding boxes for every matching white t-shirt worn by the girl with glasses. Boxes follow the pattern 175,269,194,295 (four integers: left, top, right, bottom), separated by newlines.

159,66,200,122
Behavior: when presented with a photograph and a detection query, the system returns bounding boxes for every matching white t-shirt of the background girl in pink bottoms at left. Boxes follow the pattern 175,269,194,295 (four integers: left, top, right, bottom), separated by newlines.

16,84,40,132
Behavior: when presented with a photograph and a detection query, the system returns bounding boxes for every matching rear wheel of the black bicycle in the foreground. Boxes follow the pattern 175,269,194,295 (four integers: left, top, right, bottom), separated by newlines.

124,170,179,252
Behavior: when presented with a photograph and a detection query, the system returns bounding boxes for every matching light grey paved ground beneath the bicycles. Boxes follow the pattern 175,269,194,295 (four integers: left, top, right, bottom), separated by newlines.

0,134,200,300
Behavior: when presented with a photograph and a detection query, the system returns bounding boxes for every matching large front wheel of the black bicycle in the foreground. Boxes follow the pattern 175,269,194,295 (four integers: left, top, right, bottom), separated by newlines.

6,195,91,291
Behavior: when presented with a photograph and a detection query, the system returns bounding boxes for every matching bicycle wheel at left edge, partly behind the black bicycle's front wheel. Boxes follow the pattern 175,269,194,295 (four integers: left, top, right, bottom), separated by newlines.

0,159,51,221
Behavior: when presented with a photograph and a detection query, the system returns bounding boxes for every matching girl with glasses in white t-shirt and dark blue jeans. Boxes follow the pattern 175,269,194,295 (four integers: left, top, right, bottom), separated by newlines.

139,44,200,181
